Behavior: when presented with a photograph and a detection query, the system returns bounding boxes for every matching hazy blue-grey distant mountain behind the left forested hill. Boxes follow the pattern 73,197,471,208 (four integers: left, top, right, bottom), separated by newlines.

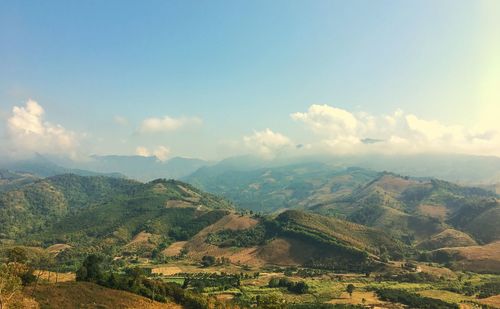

55,155,210,181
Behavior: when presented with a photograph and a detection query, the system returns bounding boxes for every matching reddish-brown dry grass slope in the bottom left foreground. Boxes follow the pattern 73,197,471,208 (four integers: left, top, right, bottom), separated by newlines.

26,282,181,309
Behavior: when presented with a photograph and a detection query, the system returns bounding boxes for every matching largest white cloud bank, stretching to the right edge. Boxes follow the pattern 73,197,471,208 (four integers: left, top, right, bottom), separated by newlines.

290,105,500,156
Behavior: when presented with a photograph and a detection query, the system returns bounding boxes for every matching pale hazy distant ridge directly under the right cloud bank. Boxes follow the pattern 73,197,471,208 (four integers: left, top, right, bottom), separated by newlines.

187,154,500,185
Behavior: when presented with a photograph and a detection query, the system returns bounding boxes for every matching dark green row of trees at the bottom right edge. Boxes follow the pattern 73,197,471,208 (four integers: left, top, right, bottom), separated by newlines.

375,289,460,309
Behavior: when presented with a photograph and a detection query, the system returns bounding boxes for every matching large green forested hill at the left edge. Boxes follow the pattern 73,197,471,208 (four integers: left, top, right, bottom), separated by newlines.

0,174,231,243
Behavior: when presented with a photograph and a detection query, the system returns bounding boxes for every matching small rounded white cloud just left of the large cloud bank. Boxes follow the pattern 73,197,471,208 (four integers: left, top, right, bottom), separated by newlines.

243,129,293,158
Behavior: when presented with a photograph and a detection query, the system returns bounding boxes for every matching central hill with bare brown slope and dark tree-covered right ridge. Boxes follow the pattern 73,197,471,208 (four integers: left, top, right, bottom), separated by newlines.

181,210,409,270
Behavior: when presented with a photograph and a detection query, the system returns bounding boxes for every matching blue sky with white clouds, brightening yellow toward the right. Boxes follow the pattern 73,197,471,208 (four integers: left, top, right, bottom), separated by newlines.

0,0,500,161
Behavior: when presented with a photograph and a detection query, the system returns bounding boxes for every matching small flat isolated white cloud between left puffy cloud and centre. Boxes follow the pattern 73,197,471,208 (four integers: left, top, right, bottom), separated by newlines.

139,116,203,133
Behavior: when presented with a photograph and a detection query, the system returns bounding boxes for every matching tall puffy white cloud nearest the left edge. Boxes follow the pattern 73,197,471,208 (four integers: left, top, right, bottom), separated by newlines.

7,100,78,157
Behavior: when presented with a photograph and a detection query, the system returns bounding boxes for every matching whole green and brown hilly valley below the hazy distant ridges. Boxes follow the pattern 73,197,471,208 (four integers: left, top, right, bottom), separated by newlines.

0,164,500,308
